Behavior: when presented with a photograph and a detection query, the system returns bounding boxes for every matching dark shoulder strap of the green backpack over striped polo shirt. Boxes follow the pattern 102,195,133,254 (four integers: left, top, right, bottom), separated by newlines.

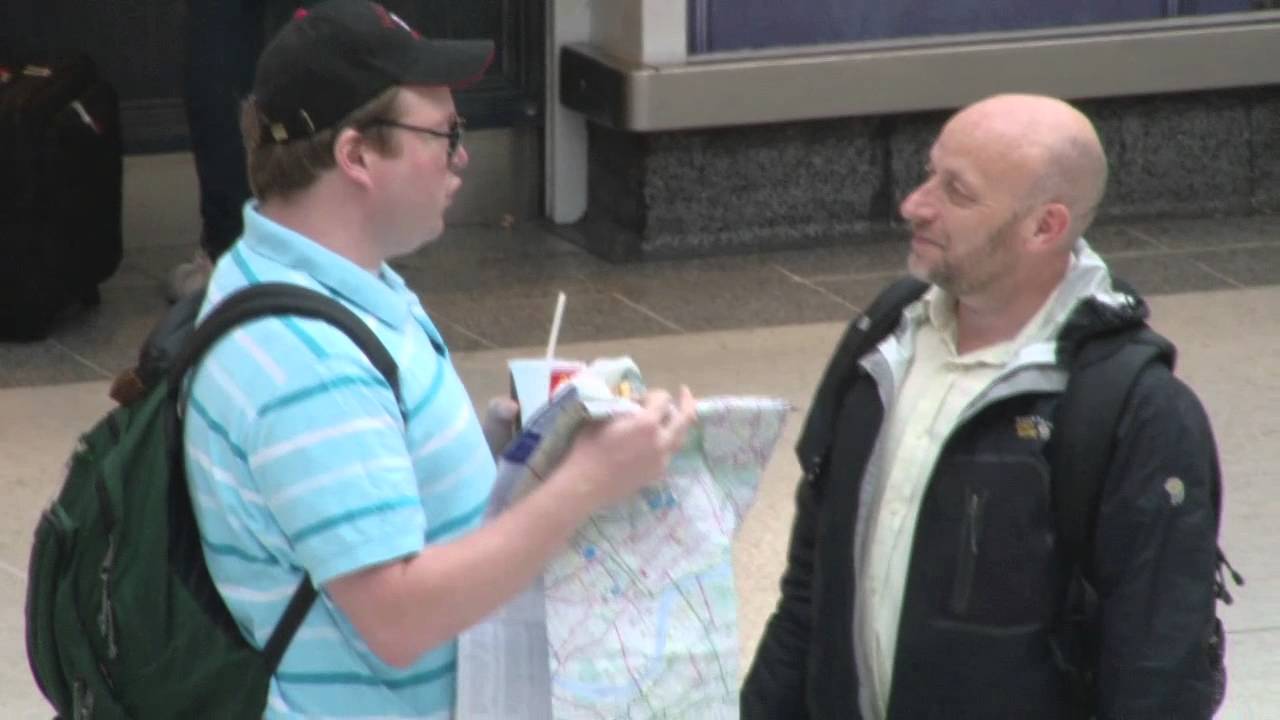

168,283,404,674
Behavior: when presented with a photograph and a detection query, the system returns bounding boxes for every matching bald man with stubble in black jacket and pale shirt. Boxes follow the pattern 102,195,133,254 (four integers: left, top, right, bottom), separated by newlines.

742,95,1220,720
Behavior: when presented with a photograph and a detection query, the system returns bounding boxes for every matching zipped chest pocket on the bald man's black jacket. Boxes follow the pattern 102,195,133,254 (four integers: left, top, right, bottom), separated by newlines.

916,455,1057,626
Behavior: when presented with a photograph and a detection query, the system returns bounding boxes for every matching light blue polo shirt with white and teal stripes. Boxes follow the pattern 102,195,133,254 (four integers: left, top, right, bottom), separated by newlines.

186,204,495,720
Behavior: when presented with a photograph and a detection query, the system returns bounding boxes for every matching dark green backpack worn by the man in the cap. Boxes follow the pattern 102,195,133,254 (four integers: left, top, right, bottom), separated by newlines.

26,283,399,720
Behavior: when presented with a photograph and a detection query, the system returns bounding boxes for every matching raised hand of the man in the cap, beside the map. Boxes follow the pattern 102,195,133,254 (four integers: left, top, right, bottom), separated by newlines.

556,387,698,507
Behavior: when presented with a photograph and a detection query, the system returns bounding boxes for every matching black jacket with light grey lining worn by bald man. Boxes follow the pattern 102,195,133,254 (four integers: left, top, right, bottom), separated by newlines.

742,257,1219,720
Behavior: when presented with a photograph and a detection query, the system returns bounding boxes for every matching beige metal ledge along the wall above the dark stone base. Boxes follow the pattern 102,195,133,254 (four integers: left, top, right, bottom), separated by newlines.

561,12,1280,132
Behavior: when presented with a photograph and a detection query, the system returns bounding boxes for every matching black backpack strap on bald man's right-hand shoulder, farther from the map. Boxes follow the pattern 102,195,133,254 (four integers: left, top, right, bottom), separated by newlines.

1050,327,1172,579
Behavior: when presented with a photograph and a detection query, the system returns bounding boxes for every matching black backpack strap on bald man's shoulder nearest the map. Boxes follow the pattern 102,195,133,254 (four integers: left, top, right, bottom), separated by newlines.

796,275,929,478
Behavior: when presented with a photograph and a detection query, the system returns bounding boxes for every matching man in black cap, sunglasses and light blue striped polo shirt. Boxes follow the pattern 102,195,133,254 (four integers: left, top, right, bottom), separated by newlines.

184,0,694,719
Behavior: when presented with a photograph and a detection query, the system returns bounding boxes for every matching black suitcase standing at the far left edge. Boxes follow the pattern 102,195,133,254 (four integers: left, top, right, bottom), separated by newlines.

0,56,123,340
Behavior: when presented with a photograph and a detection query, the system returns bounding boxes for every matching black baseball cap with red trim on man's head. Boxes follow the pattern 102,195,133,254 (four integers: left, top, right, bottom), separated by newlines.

253,0,493,143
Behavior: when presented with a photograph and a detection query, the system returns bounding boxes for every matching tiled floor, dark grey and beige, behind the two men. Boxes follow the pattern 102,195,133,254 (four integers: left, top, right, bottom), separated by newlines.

0,156,1280,720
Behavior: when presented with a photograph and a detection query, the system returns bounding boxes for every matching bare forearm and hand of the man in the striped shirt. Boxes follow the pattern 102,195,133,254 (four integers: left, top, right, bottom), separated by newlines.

325,388,696,667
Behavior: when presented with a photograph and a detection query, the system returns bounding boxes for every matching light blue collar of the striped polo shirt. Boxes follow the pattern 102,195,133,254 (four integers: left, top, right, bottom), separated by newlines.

243,201,417,328
